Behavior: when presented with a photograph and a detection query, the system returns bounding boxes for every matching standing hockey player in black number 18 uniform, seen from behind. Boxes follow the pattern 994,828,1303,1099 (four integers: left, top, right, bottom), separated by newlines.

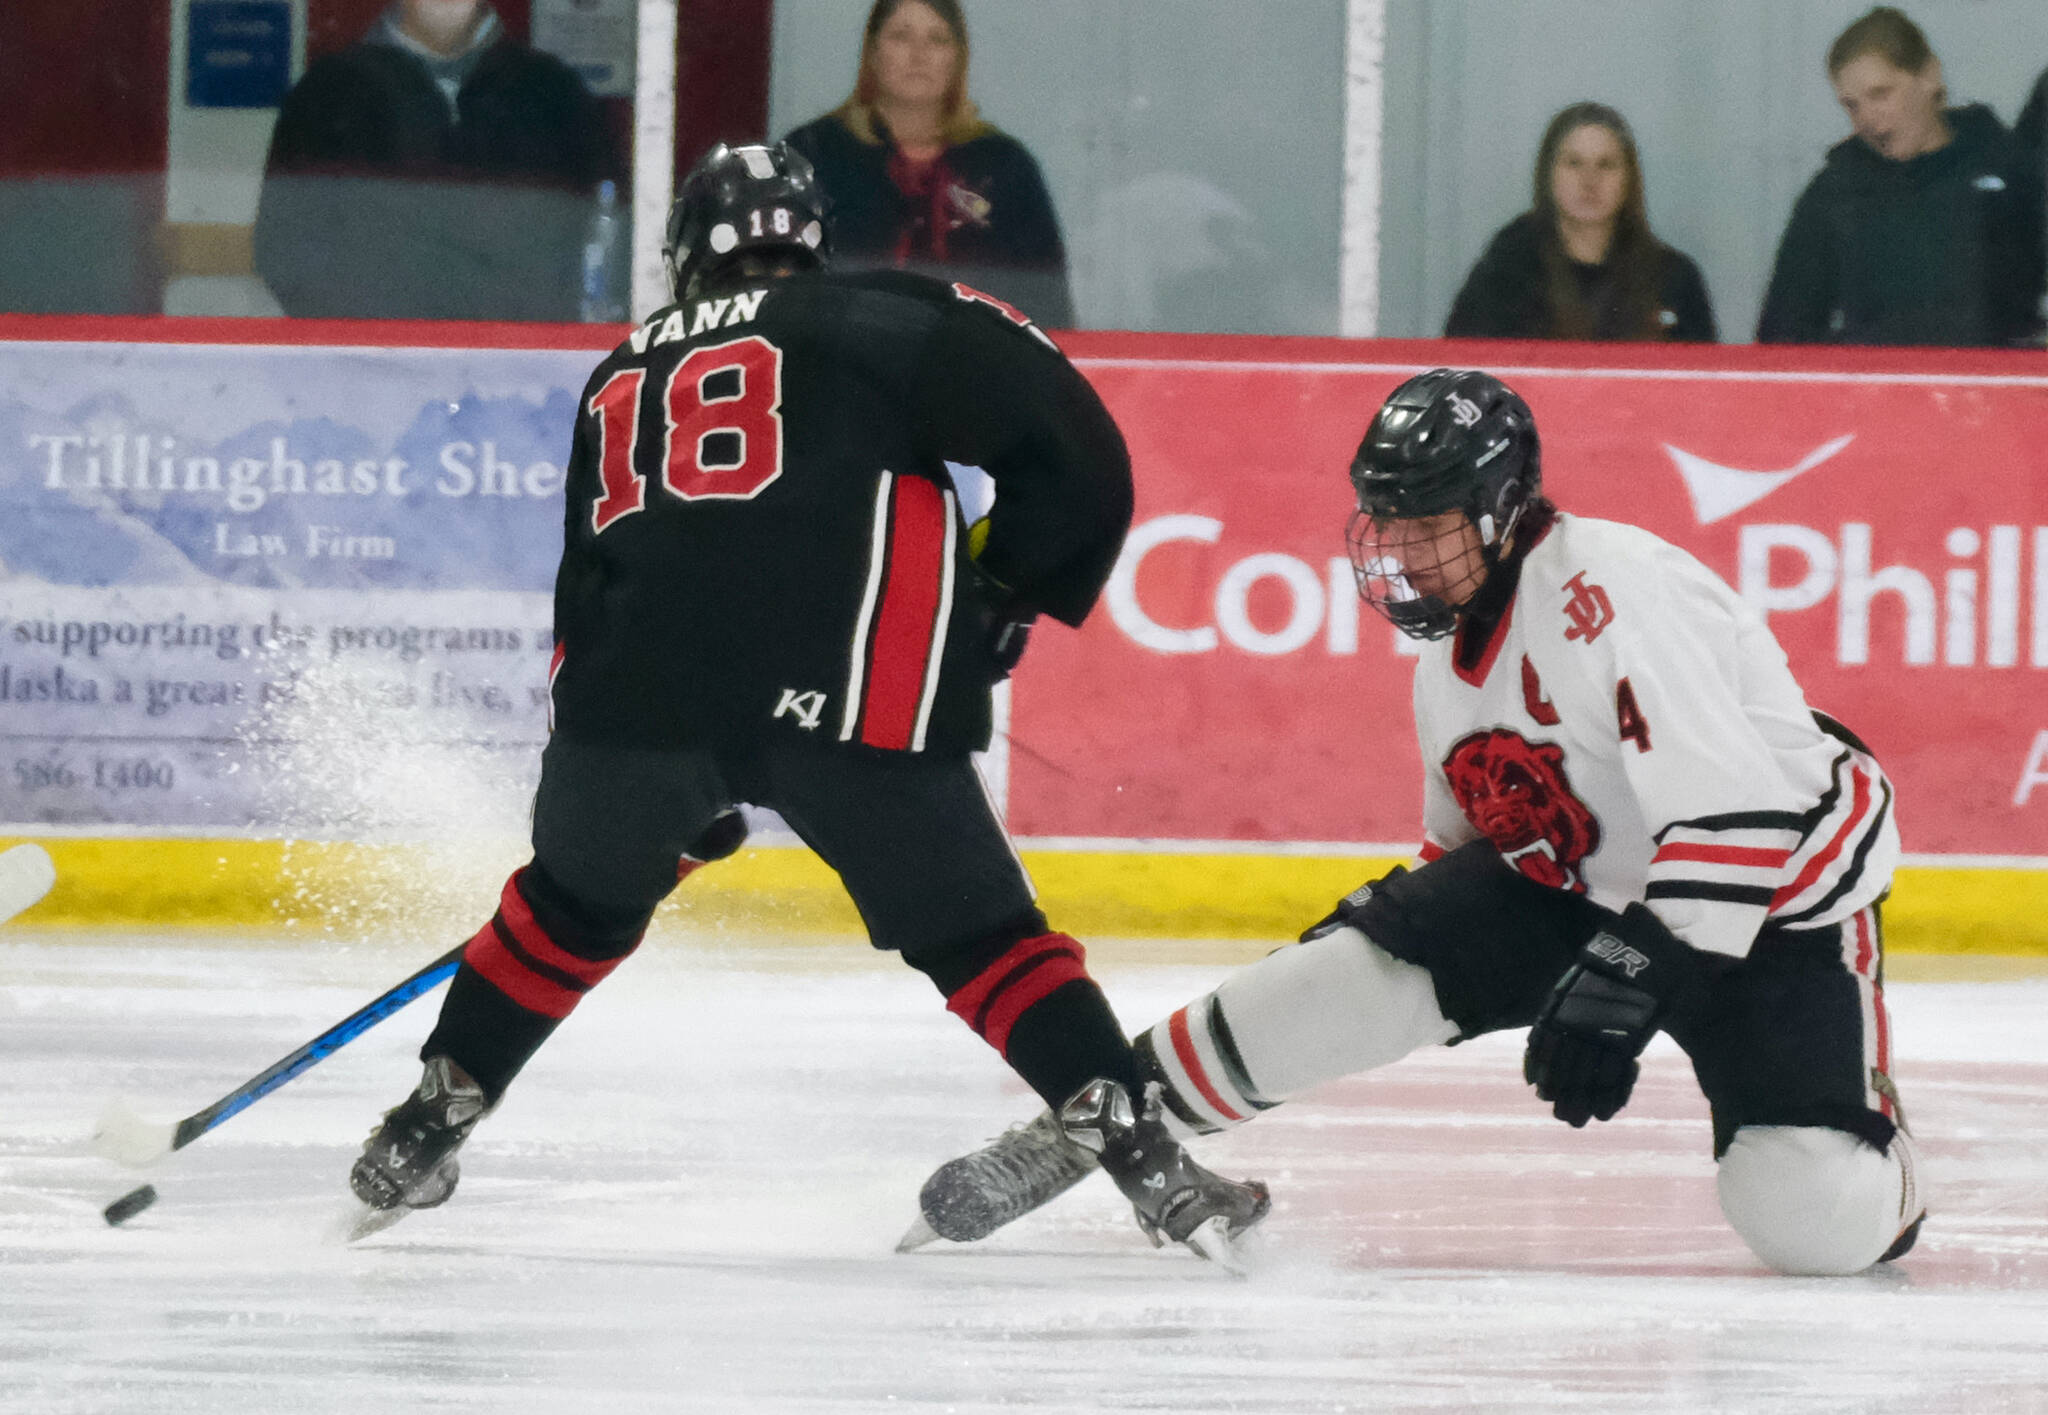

350,145,1266,1261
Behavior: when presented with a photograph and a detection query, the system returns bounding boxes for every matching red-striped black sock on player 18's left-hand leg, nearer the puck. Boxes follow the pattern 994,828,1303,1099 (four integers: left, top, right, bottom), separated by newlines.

420,864,647,1106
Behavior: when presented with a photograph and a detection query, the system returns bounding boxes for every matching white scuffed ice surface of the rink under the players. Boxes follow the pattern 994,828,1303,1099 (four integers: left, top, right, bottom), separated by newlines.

0,933,2048,1415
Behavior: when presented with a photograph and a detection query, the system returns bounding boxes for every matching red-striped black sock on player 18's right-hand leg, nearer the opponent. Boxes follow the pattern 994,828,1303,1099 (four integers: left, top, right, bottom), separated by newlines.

913,917,1139,1108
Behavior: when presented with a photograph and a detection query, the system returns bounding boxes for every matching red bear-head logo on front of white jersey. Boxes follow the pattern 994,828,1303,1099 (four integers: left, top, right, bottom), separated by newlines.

1444,727,1599,895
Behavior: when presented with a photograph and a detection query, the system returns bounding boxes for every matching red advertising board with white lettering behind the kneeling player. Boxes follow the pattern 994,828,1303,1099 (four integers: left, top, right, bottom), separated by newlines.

1010,334,2048,858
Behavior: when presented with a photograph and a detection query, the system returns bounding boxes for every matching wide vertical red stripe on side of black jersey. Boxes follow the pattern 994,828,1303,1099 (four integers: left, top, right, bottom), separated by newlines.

860,477,948,752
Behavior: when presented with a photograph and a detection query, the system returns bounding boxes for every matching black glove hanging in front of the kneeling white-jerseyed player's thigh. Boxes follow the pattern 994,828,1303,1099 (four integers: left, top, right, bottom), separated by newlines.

1522,903,1708,1128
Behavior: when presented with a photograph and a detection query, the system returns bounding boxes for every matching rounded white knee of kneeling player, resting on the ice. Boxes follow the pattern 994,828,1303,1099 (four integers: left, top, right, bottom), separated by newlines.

1714,1124,1921,1278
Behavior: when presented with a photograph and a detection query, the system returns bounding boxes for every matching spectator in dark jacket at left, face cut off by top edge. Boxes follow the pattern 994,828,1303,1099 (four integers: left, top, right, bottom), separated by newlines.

256,0,616,319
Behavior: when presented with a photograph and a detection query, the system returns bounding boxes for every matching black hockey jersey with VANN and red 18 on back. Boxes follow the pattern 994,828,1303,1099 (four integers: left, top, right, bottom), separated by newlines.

551,272,1130,752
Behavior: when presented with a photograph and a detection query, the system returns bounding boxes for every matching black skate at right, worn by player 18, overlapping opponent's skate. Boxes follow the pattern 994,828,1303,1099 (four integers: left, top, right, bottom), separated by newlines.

1059,1081,1272,1274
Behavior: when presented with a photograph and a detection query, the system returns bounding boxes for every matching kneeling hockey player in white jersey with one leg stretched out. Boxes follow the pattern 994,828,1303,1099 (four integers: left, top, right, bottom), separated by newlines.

905,369,1925,1274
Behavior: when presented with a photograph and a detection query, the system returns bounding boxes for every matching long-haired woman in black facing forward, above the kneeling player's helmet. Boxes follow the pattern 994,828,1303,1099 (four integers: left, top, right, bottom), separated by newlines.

1444,102,1716,344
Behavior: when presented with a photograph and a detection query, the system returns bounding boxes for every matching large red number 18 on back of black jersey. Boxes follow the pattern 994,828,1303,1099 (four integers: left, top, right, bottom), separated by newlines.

590,334,782,532
